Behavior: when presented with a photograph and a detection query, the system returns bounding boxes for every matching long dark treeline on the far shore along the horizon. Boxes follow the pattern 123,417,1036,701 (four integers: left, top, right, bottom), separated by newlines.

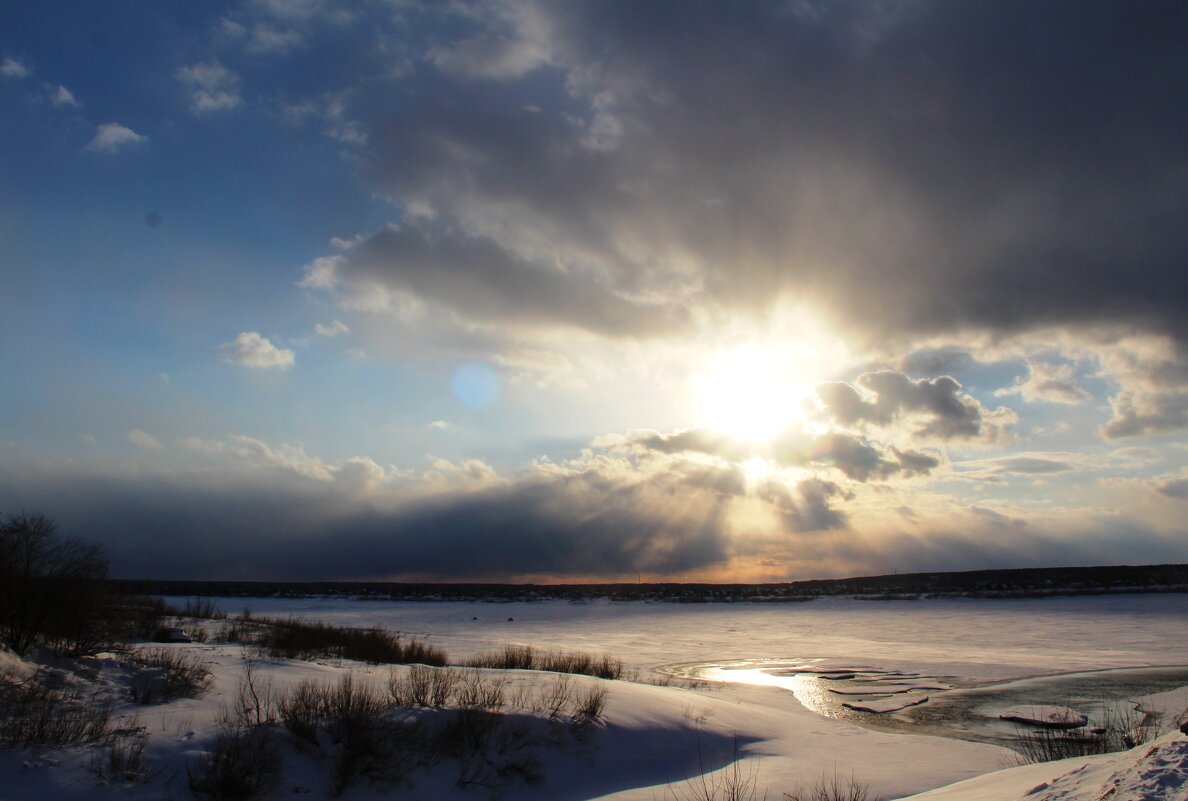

114,565,1188,603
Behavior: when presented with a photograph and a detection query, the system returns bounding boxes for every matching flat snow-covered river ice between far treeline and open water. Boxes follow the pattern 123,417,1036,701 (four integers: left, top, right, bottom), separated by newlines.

182,594,1188,681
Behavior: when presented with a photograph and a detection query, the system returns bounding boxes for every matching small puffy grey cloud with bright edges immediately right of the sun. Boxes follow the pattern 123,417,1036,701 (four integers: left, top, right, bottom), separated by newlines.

817,370,1017,442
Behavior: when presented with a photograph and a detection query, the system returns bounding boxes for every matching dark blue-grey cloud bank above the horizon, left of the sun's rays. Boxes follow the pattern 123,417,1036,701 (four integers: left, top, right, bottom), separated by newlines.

0,465,736,579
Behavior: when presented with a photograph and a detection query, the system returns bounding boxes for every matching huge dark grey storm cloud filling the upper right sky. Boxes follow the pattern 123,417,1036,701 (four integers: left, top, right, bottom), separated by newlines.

325,0,1188,347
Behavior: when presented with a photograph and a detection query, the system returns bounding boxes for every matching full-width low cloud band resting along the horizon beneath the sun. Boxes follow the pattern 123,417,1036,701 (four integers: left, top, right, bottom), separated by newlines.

0,427,1188,580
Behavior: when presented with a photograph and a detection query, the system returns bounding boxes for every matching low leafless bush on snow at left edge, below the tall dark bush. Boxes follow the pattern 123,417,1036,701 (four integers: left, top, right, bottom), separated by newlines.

0,670,112,749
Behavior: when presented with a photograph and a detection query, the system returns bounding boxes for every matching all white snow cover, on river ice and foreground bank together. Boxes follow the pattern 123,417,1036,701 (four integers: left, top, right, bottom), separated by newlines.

0,595,1188,801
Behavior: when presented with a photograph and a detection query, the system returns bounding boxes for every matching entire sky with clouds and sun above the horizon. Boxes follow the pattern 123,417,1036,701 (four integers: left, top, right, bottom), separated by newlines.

0,0,1188,581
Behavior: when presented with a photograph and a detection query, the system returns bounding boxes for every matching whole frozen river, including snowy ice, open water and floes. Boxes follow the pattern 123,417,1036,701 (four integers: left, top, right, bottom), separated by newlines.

171,594,1188,744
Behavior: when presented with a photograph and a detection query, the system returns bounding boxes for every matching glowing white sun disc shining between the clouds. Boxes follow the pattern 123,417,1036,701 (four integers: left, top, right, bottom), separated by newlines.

695,345,813,442
